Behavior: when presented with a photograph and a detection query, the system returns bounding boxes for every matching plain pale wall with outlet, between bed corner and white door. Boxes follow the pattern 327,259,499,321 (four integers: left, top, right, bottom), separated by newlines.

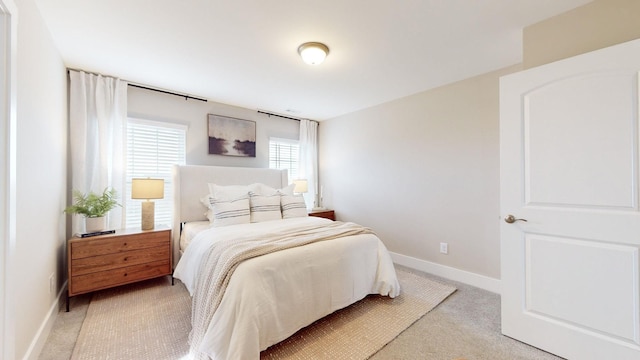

319,67,519,279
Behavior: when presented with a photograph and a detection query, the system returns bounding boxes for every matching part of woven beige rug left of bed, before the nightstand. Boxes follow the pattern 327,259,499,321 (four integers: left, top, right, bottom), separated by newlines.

71,276,191,360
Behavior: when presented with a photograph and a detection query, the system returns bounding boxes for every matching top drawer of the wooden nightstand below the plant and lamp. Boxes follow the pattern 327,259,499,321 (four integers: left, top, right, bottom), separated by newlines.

71,232,170,259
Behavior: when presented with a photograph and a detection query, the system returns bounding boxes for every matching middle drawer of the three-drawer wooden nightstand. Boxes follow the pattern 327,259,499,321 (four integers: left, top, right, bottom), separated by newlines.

71,246,171,276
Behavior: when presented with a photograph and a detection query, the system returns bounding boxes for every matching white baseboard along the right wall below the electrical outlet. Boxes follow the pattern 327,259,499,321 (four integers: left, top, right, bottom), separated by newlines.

390,252,500,294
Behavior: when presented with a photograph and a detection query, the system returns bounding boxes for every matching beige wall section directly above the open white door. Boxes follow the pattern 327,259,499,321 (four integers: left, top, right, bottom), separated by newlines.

523,0,640,69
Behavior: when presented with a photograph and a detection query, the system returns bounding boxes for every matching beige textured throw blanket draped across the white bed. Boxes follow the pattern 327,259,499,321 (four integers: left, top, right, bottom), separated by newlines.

190,221,372,359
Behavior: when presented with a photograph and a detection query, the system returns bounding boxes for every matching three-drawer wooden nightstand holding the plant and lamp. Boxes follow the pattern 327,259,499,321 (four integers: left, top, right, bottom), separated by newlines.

67,227,171,311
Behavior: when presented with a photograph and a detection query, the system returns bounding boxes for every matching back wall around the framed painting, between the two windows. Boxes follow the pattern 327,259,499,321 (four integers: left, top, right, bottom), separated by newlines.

127,86,300,167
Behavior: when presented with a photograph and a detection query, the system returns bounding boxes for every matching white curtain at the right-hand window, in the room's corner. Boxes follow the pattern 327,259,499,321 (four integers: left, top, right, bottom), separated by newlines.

298,119,320,208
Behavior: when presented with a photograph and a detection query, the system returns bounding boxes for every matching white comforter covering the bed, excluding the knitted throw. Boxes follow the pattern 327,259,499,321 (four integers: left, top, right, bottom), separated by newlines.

174,217,400,359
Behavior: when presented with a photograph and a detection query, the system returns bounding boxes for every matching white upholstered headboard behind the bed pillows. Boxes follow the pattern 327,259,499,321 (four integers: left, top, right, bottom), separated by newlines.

172,165,289,267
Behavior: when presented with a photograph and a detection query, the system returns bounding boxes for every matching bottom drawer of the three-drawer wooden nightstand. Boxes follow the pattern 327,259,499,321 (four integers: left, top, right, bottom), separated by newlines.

69,260,171,296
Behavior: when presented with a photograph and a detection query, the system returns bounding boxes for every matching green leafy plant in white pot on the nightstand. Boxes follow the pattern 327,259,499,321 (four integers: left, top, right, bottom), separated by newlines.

64,188,121,232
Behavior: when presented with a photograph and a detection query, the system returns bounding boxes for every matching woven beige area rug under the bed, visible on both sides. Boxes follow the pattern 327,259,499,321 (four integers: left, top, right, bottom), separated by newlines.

71,270,455,360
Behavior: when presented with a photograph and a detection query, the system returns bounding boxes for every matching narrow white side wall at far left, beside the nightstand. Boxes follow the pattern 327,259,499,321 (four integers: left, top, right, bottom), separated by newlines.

13,0,67,358
